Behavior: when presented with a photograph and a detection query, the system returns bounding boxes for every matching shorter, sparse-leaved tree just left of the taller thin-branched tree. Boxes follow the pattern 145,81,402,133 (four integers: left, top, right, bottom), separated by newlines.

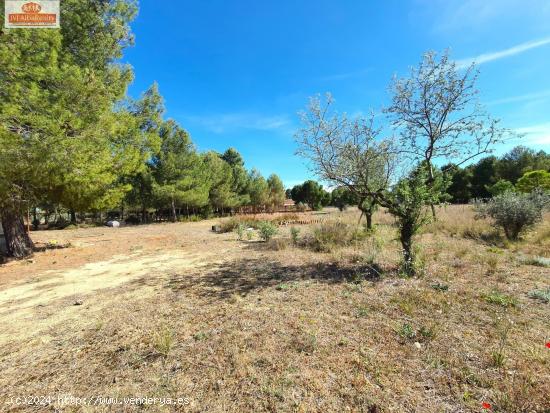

296,94,395,229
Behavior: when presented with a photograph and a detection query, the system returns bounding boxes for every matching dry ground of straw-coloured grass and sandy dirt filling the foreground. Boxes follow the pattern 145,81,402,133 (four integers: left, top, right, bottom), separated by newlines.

0,207,550,412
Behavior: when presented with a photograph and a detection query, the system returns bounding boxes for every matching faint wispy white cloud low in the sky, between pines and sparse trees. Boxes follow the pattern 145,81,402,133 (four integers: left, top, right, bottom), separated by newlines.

186,112,291,133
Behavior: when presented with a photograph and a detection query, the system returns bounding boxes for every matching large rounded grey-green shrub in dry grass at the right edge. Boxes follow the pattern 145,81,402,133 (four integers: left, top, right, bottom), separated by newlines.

475,191,550,241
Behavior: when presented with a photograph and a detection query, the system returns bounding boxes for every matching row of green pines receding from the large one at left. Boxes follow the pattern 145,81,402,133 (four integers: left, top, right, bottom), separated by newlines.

0,0,285,257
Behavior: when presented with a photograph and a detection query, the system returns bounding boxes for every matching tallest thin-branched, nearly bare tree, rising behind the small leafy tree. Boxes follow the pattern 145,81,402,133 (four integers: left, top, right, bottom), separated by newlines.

385,51,509,218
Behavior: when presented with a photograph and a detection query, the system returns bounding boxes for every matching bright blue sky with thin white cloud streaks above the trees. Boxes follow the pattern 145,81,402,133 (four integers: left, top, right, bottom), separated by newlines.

124,0,550,186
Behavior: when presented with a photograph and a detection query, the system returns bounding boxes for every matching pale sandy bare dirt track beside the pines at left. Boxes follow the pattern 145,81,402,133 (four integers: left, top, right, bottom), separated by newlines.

0,222,235,346
